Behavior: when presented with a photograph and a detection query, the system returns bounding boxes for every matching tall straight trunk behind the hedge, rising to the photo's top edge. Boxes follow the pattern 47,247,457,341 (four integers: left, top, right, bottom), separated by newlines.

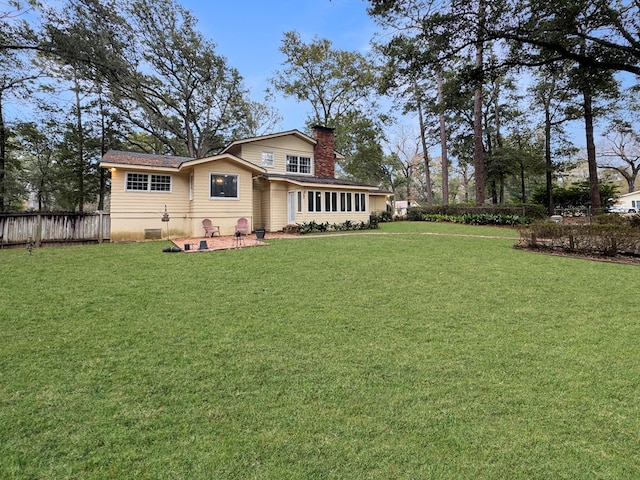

473,0,485,205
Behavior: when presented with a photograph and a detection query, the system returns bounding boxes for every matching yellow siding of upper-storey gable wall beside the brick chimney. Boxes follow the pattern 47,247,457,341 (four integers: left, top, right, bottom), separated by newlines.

239,136,314,175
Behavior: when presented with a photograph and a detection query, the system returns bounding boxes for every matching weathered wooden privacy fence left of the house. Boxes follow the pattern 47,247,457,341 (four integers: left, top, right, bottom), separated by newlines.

0,212,111,247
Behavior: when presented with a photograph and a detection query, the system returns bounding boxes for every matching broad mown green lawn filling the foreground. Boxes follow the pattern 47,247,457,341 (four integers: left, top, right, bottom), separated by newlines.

0,222,640,479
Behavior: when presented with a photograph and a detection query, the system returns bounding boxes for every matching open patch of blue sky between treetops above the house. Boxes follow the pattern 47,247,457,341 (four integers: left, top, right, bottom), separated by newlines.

180,0,376,130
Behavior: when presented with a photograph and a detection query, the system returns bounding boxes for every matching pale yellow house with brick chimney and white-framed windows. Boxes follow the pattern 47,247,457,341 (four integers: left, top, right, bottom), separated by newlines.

100,127,390,240
